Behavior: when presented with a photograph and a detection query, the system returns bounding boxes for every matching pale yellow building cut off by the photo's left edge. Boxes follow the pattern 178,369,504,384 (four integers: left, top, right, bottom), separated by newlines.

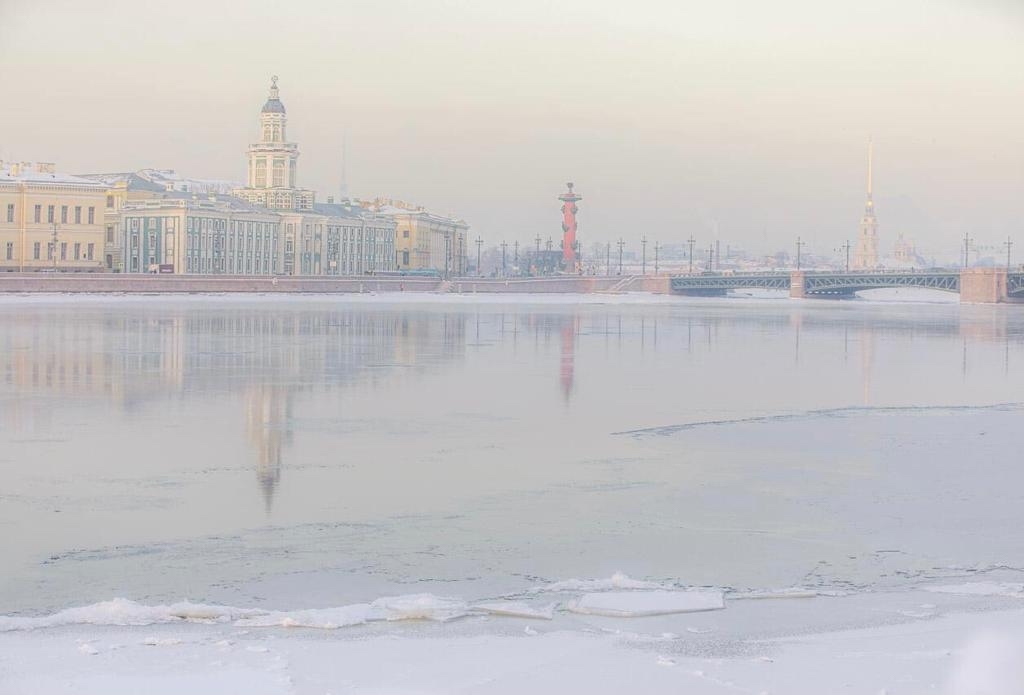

0,163,105,272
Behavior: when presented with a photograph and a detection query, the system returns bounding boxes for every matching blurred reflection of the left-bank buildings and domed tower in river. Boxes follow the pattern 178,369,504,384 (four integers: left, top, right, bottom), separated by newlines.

0,305,467,513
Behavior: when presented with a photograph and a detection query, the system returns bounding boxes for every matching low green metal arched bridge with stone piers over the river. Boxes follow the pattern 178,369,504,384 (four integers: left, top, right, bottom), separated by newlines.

671,268,1024,304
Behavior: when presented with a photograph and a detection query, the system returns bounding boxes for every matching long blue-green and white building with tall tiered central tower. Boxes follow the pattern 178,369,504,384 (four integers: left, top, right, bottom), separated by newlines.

109,78,396,275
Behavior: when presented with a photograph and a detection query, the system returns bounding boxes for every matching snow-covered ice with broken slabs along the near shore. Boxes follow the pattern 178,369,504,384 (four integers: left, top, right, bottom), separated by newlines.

0,575,1024,695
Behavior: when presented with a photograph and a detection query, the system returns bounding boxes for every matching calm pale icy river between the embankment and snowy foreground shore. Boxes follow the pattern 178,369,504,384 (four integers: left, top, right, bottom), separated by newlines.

0,296,1024,692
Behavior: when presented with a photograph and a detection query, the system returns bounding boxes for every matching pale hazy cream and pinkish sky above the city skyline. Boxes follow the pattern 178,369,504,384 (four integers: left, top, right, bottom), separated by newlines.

0,0,1024,258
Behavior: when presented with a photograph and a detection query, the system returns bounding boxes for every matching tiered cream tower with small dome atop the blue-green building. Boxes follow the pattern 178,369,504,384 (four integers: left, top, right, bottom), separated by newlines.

234,76,315,210
